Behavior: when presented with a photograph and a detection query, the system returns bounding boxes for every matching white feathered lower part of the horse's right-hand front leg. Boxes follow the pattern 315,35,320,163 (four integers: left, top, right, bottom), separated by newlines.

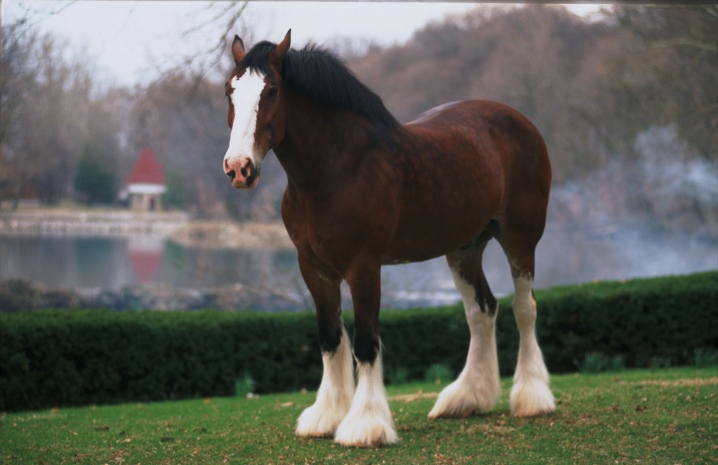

334,355,399,447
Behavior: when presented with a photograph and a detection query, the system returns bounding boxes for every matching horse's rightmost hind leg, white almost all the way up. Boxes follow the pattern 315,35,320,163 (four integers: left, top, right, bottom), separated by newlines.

499,231,556,417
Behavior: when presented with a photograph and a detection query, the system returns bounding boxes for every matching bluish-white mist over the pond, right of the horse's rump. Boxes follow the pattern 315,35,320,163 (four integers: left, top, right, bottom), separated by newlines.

536,126,718,287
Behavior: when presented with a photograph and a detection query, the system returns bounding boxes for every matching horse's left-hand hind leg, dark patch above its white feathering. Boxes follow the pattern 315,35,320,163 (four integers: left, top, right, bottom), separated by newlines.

429,234,501,418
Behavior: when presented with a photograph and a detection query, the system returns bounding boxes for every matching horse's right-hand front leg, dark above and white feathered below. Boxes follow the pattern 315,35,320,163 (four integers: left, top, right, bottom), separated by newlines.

334,265,399,447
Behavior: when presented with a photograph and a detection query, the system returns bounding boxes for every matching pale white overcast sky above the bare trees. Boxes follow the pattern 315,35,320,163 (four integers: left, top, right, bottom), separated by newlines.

2,0,599,86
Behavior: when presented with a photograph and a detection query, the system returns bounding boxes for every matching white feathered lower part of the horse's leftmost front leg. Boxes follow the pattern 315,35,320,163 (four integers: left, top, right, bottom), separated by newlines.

296,328,354,437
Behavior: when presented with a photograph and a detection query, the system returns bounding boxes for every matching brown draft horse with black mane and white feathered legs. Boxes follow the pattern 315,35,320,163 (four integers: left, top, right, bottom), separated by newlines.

223,30,555,447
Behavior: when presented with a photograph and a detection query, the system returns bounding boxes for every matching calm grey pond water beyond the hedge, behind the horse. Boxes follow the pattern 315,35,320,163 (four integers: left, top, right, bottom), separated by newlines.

0,223,718,310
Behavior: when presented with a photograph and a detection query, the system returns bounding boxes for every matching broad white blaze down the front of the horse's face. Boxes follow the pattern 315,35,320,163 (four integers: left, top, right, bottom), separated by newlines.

224,72,264,170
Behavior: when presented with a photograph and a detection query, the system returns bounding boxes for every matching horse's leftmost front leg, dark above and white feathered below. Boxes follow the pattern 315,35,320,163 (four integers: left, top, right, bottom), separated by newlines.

296,256,354,437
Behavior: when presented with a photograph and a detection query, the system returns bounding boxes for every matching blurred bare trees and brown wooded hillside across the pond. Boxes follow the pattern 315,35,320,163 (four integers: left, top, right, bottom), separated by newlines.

0,5,718,236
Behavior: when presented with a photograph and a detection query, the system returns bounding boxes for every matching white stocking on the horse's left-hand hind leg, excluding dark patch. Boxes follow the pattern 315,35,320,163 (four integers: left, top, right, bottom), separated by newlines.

429,269,501,418
